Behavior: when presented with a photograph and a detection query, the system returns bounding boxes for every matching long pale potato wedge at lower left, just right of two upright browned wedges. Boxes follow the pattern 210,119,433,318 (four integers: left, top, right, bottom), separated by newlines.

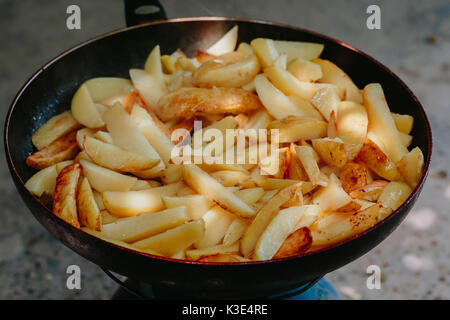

101,207,188,242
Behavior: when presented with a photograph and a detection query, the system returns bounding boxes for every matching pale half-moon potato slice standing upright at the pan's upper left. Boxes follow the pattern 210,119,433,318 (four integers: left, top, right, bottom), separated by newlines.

71,84,105,128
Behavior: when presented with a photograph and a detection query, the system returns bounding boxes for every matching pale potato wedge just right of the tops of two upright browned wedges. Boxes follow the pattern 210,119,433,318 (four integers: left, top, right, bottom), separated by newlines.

80,160,137,192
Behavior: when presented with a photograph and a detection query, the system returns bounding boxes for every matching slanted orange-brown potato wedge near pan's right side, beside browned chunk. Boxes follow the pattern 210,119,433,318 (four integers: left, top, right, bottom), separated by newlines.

356,138,400,181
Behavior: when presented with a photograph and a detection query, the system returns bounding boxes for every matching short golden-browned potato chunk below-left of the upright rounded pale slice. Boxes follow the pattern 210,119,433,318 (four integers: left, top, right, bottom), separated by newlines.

311,138,347,168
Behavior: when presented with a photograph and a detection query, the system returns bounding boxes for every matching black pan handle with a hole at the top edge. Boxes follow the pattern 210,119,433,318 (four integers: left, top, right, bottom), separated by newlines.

124,0,167,27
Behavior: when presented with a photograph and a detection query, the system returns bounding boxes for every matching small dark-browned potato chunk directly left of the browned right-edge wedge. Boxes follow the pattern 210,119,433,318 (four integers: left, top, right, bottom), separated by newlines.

339,161,372,194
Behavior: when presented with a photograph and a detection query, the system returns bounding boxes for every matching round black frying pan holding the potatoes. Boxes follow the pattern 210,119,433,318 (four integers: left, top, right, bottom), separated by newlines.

4,1,432,298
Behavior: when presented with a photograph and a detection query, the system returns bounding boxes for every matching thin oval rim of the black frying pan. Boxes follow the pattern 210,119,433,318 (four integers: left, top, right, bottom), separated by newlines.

3,16,433,266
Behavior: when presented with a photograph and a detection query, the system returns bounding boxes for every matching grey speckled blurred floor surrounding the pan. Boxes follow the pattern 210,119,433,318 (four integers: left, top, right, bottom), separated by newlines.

0,0,450,299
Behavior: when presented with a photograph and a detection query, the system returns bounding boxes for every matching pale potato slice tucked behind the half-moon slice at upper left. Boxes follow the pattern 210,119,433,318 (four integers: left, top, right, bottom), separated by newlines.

84,77,134,102
